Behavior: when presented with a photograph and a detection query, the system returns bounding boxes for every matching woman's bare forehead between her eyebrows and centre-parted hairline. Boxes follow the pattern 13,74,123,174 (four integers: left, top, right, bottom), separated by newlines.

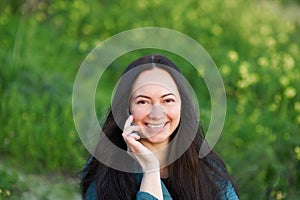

132,68,178,94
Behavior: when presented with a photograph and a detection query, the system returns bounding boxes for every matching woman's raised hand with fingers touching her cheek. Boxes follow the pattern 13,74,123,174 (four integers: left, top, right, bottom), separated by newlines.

122,115,159,173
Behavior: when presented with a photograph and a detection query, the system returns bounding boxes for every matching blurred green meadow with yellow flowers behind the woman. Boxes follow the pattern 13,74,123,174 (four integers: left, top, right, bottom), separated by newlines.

0,0,300,199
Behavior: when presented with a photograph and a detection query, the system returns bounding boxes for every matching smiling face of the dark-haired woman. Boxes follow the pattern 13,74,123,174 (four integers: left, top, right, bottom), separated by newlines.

130,68,181,147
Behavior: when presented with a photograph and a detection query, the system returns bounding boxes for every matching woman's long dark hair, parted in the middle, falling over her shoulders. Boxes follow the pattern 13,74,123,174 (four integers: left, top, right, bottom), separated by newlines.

80,55,239,200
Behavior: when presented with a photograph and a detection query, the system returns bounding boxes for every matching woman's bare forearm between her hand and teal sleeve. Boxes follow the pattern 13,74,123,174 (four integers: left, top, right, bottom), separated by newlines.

140,169,163,200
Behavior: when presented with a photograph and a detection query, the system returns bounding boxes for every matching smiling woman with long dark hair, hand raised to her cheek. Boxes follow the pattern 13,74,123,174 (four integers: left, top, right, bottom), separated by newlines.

81,55,238,200
